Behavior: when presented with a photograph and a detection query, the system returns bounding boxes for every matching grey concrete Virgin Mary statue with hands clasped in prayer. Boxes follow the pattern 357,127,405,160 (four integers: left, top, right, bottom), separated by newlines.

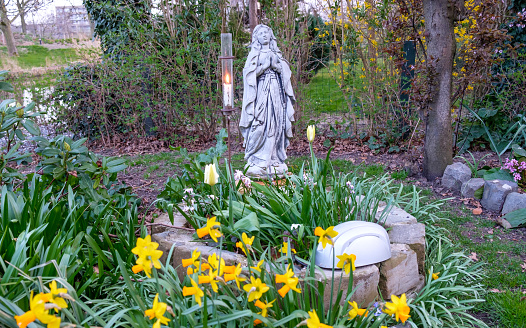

239,24,296,178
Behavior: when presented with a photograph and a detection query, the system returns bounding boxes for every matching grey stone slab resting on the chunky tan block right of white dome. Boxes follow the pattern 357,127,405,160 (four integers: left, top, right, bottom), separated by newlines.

388,223,426,275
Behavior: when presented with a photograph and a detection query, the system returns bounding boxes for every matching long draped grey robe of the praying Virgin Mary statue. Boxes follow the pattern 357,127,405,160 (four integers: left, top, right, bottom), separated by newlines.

239,50,295,168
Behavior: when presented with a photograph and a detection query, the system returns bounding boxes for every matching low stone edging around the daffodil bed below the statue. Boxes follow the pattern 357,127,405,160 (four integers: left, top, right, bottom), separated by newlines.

152,201,426,306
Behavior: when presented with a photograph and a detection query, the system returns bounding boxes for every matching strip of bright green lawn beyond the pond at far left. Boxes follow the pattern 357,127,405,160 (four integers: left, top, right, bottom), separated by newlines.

0,46,80,70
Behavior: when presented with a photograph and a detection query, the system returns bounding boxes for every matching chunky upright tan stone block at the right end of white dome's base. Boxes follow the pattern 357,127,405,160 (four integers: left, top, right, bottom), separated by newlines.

378,244,423,299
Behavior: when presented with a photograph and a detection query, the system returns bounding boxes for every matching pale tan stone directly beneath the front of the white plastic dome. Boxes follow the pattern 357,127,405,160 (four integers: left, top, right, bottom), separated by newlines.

310,264,380,309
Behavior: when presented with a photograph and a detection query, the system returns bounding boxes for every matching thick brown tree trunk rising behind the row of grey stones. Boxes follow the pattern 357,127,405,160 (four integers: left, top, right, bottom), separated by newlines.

423,0,456,180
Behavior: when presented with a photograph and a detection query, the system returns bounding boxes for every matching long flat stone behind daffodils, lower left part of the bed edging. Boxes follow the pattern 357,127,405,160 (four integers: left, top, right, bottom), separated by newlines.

152,230,247,280
